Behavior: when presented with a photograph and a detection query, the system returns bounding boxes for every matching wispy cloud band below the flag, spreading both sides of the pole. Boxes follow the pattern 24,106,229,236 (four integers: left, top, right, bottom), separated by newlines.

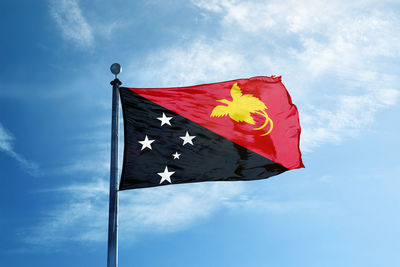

23,179,333,250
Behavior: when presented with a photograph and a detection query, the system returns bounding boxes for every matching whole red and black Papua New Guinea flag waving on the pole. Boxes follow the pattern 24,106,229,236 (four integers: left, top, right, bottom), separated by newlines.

120,77,304,190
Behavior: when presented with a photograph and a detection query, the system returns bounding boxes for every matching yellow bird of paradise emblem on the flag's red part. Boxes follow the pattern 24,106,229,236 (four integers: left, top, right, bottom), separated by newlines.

210,83,274,136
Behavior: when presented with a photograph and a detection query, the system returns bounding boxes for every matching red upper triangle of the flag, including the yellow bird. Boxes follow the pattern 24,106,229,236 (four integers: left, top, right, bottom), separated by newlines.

129,76,304,169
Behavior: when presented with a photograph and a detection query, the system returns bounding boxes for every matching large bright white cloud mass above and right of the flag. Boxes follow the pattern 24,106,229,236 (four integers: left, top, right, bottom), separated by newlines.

128,0,400,151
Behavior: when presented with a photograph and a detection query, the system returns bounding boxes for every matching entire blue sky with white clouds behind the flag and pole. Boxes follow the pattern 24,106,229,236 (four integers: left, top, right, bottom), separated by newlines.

0,0,400,267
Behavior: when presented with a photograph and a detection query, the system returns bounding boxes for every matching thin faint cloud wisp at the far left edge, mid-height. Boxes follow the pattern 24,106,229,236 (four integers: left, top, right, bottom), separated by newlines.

0,124,39,176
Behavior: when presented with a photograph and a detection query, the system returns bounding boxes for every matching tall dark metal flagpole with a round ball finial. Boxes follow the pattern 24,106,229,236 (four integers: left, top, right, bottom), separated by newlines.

107,63,122,267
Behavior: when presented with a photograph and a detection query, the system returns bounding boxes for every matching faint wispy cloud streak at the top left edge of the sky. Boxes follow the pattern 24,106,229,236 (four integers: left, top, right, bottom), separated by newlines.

50,0,94,47
